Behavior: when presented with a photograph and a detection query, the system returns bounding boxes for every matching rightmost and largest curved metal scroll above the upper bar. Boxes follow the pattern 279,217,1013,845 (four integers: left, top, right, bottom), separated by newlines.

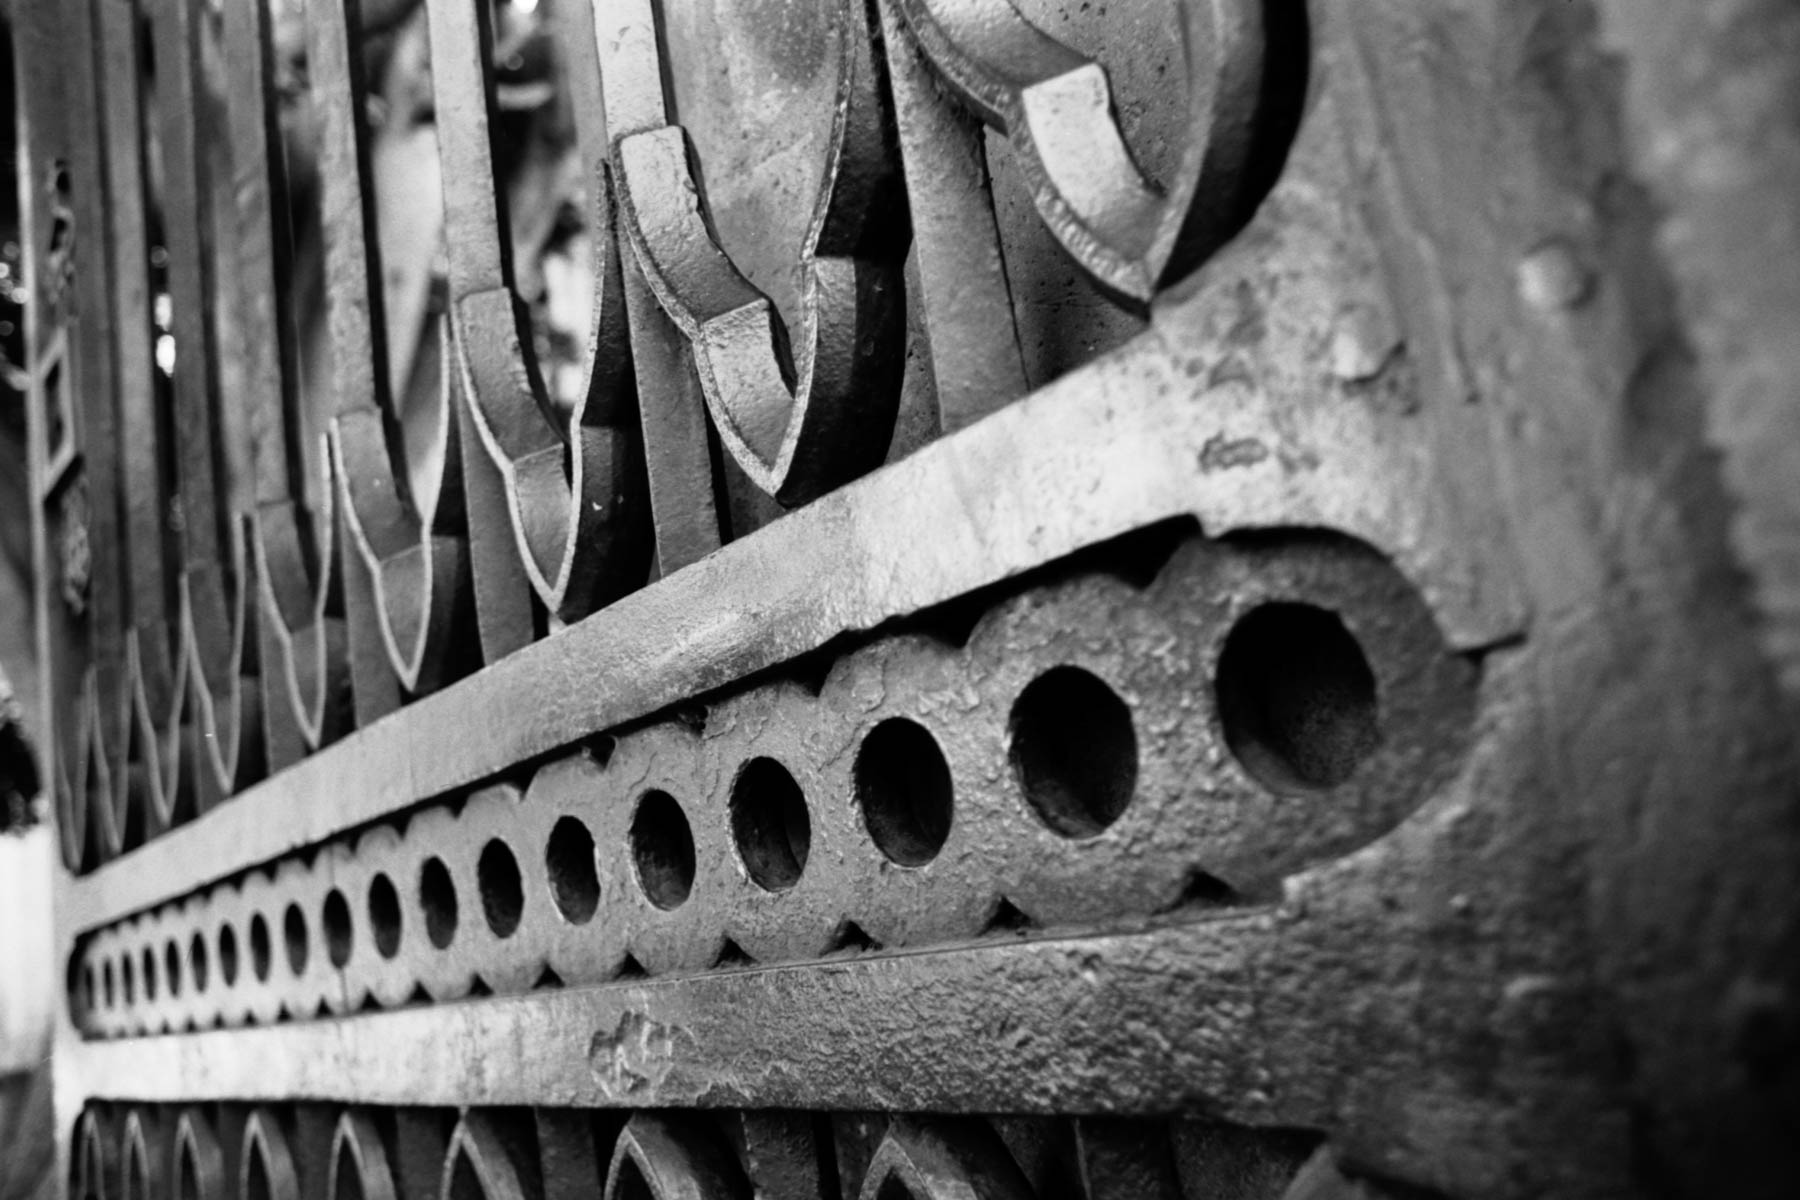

896,0,1264,309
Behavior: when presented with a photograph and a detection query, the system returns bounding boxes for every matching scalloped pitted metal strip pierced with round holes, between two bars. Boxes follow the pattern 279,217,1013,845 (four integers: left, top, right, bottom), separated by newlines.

70,527,1478,1036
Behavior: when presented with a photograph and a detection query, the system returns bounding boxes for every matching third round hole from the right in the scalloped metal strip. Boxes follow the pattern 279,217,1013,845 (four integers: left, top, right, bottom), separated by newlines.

857,716,950,867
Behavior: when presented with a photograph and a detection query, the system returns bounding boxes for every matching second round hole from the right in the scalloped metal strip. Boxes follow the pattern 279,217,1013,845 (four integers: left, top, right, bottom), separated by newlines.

1010,667,1138,838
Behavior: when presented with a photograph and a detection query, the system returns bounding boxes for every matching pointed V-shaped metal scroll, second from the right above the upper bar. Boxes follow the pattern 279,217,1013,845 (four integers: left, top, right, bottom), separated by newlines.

596,0,907,506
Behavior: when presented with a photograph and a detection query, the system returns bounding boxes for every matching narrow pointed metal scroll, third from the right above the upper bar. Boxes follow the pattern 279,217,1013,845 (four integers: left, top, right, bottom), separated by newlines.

428,0,644,621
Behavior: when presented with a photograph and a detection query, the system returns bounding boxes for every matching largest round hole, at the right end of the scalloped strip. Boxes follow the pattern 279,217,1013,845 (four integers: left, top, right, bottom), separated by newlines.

1215,603,1381,790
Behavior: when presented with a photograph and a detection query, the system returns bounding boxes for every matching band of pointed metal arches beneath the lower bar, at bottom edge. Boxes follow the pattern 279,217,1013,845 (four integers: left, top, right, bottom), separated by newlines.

70,1103,1332,1200
